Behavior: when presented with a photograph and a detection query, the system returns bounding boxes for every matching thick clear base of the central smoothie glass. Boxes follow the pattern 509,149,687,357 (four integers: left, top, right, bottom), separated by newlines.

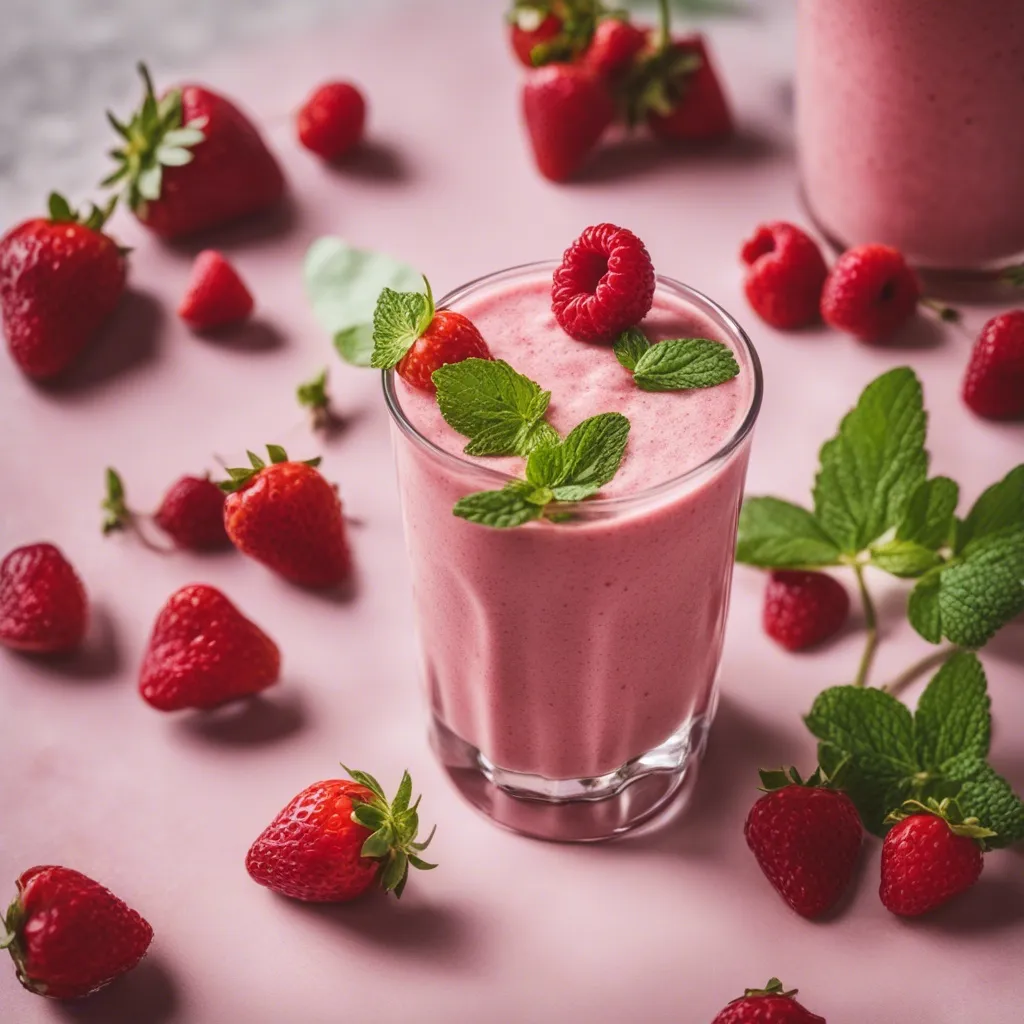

430,715,712,843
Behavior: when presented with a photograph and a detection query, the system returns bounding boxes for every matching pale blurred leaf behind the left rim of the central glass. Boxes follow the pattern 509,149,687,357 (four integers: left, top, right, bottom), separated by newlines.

303,237,423,366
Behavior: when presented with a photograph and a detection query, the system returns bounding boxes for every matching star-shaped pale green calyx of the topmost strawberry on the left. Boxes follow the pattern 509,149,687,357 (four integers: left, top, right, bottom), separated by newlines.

100,62,206,211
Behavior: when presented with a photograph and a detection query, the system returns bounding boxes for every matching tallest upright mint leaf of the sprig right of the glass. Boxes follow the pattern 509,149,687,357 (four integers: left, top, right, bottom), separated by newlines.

814,367,928,555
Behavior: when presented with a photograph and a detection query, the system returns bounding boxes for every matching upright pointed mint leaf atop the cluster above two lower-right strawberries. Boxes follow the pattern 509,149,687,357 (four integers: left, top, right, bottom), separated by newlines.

913,652,991,771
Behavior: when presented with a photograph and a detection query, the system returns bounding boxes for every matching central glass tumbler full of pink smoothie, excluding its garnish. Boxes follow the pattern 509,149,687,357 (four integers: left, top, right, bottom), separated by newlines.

384,263,761,841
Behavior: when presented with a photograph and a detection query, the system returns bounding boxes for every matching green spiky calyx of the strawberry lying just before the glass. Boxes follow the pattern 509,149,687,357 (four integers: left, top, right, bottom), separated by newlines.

341,764,437,899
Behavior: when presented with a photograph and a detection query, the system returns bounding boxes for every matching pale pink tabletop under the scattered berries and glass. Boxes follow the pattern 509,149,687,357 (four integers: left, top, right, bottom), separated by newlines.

0,0,1024,1024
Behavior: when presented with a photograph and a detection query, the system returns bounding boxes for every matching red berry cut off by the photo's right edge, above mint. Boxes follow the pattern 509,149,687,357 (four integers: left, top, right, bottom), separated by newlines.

964,309,1024,420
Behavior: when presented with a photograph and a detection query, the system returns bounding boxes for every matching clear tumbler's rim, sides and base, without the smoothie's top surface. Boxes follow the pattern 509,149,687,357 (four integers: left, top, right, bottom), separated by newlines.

384,262,762,841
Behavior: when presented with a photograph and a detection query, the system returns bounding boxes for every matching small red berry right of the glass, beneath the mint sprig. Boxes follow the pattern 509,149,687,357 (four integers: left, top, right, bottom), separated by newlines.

763,569,850,650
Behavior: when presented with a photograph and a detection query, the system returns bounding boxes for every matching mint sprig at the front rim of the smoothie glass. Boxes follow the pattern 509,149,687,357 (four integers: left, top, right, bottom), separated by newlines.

456,413,630,529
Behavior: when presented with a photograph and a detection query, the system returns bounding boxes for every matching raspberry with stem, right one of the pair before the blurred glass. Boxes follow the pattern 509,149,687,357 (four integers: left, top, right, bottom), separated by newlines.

821,245,921,343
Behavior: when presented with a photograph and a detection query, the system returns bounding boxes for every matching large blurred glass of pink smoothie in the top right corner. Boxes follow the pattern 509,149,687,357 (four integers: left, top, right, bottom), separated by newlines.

797,0,1024,270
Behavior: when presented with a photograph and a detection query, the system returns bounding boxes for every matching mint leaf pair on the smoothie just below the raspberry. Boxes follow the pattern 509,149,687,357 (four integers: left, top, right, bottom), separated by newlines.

614,327,739,391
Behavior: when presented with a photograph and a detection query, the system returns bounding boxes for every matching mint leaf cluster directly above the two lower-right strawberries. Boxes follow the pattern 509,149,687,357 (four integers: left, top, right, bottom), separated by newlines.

806,652,1024,849
